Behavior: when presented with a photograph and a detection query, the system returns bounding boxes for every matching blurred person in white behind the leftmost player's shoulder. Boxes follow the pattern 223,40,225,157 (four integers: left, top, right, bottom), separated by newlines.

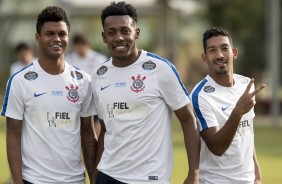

10,42,36,75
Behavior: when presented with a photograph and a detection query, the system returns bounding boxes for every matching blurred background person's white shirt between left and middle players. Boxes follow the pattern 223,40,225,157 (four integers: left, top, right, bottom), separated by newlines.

65,50,107,75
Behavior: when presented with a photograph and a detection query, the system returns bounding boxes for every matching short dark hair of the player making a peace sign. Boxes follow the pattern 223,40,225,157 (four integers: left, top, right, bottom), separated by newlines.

203,27,233,53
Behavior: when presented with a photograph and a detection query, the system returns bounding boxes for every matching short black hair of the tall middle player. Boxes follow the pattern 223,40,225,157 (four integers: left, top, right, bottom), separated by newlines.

101,1,137,26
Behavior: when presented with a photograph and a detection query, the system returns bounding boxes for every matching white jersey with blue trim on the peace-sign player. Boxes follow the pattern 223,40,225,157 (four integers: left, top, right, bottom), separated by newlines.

190,74,255,184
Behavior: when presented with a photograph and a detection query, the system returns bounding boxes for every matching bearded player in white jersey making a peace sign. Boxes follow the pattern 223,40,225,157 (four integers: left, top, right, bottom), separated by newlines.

190,27,265,184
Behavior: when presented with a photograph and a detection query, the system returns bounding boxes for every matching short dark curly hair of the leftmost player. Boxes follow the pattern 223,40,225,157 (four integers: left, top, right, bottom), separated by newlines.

36,6,70,34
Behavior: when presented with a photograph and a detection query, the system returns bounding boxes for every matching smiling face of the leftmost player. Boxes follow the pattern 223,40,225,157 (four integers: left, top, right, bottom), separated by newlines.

35,21,69,60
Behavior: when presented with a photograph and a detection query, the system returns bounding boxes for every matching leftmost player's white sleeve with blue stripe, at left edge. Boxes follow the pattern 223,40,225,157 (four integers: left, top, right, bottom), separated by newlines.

1,75,25,120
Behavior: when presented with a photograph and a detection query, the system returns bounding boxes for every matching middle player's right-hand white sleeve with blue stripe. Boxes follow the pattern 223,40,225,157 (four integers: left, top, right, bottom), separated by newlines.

157,60,190,110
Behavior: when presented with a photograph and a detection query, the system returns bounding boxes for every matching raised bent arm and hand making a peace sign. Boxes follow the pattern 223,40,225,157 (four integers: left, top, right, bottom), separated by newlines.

201,79,265,156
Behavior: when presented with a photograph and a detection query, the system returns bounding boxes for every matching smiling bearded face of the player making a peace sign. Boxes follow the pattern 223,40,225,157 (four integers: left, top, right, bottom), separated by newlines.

202,36,238,79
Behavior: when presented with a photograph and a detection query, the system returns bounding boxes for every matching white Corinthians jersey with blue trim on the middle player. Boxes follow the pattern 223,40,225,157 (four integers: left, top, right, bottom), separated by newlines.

92,51,190,184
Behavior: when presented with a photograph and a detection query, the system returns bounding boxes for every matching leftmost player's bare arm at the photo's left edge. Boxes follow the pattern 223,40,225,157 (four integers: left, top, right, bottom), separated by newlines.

6,117,23,184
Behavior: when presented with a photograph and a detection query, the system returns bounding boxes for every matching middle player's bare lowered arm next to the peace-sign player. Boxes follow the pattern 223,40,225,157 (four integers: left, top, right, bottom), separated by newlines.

175,104,200,184
